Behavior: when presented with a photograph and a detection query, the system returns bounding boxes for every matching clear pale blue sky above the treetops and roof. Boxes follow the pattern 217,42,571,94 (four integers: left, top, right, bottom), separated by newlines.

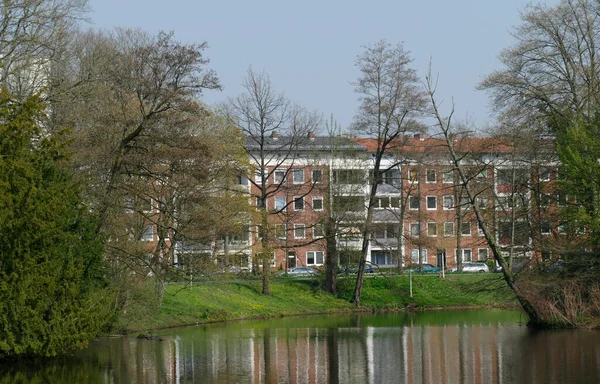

89,0,558,132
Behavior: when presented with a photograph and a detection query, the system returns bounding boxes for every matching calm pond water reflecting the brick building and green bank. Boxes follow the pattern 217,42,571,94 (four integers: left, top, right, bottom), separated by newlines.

0,310,600,384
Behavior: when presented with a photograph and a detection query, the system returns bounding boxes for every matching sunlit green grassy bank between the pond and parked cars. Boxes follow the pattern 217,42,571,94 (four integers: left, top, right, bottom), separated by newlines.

118,274,515,331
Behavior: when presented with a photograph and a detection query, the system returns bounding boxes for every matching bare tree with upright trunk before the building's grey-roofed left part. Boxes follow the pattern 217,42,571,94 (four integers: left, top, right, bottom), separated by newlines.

227,69,320,295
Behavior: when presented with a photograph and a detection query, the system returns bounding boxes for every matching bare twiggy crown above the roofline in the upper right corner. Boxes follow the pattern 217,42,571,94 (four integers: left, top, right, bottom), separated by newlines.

480,0,600,130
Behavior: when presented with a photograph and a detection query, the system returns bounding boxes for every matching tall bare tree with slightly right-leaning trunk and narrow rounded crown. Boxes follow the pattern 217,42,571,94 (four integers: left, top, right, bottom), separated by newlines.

351,41,426,306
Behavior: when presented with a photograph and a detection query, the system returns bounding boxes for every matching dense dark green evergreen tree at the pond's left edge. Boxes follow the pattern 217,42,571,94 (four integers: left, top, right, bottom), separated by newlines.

0,90,110,358
